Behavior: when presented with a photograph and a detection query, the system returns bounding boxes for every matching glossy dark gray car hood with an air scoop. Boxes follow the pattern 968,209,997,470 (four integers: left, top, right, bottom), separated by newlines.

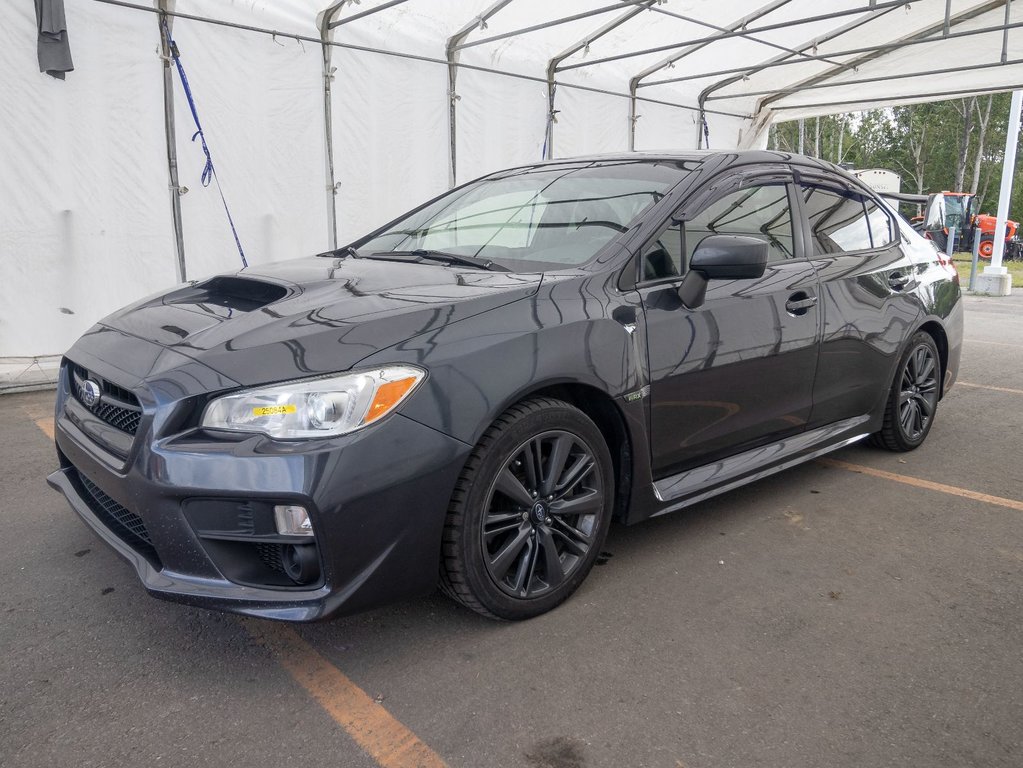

100,257,542,386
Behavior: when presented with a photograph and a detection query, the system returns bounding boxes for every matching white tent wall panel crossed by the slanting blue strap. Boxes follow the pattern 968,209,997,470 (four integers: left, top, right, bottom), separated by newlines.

165,14,328,279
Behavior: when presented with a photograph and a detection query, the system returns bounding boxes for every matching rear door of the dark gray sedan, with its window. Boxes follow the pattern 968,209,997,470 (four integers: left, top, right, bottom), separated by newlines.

799,177,922,426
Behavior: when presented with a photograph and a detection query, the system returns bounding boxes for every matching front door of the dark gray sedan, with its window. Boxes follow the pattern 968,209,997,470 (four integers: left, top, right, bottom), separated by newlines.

637,171,819,478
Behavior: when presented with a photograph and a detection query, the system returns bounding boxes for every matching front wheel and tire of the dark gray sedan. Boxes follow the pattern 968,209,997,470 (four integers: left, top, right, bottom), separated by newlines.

440,398,615,621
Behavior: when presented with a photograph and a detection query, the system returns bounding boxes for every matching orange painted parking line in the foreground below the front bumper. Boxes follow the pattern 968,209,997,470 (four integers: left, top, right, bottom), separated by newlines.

241,619,445,768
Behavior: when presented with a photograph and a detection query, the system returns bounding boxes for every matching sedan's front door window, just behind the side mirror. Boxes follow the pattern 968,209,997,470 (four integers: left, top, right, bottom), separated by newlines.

642,184,795,280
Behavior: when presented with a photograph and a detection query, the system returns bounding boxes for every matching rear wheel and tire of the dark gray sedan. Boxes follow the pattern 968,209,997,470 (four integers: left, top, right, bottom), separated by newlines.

872,331,941,451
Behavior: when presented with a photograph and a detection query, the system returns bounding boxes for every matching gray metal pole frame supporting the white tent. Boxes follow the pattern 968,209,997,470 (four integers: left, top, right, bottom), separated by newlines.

95,0,1023,255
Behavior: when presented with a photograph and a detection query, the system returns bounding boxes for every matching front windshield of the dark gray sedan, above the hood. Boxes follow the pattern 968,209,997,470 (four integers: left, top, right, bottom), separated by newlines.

355,161,693,272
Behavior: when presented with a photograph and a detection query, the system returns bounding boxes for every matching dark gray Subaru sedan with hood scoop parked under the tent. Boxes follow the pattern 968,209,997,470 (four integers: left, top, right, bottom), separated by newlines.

49,152,963,621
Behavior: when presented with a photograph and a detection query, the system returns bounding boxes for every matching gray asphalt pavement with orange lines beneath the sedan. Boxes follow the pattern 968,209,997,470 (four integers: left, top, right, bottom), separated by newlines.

0,296,1023,768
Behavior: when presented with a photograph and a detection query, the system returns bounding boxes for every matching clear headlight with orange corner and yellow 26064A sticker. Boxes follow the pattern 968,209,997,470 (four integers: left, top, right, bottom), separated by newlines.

203,365,427,440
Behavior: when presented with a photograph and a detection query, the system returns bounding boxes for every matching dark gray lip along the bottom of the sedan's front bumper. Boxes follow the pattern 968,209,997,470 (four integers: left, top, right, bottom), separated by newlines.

46,467,329,622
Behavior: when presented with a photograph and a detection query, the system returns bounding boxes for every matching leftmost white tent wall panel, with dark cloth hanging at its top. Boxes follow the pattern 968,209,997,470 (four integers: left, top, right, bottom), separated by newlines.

0,2,175,376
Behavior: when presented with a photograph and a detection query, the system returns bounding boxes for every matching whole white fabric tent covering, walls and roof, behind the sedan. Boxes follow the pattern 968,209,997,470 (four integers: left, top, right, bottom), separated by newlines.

0,0,1023,388
